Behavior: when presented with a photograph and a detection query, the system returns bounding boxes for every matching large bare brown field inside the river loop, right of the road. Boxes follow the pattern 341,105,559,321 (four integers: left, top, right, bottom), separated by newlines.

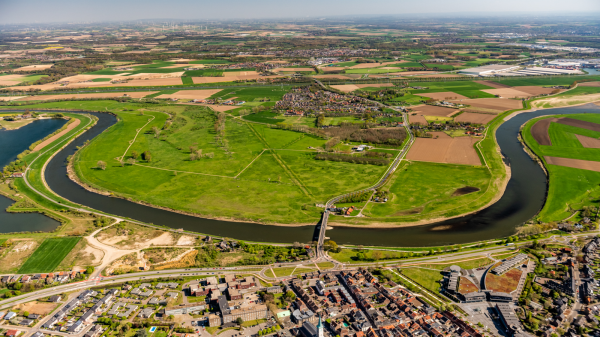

406,132,481,165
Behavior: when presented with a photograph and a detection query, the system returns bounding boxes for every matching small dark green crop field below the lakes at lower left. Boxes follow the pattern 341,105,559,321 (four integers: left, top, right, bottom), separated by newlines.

19,237,81,274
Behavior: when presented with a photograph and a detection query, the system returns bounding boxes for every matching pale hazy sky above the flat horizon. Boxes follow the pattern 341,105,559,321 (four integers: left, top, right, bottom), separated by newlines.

0,0,600,25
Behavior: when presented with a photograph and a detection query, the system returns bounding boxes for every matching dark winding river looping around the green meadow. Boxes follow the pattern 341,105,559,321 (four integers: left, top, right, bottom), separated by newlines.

3,104,600,247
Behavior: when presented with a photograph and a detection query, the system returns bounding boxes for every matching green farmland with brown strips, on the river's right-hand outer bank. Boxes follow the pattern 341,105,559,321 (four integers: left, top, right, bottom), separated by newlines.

522,114,600,222
